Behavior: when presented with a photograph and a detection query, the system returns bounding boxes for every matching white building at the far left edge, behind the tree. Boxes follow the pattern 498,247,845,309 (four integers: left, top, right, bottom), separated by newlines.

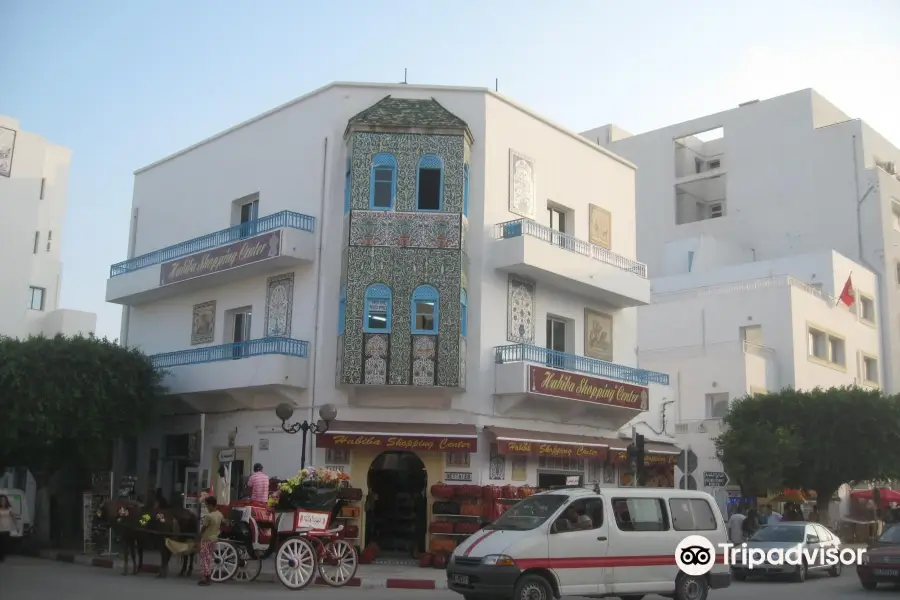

0,115,97,338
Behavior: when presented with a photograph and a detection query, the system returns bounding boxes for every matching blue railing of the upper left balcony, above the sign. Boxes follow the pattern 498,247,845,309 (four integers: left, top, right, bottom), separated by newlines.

109,210,316,277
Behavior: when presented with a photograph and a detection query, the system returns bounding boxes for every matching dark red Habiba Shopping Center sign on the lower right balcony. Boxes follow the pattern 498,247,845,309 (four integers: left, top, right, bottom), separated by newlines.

528,367,650,410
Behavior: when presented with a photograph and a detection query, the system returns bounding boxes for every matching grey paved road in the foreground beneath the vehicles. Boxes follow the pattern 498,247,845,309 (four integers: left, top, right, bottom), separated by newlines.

0,556,896,600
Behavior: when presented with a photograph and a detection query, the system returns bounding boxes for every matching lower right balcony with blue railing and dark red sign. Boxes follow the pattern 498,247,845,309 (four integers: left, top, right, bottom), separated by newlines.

494,344,669,430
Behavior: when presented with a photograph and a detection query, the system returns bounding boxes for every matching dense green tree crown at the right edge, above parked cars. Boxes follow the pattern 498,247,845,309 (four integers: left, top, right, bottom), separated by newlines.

716,387,900,498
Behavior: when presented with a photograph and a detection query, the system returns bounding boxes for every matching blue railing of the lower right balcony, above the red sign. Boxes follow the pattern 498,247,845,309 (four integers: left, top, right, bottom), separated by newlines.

494,344,669,385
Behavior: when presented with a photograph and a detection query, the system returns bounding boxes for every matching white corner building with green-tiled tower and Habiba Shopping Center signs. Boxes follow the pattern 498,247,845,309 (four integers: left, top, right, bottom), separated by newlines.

107,83,679,548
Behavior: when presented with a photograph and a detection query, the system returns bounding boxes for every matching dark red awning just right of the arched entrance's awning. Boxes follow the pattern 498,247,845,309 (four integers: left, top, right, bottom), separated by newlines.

484,427,614,461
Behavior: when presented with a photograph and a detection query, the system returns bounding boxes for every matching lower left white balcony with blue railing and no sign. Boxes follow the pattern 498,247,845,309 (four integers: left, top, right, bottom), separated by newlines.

150,338,309,412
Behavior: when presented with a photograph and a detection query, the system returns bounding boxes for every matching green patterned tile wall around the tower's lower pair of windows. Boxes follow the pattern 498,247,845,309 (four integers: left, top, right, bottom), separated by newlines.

340,246,464,387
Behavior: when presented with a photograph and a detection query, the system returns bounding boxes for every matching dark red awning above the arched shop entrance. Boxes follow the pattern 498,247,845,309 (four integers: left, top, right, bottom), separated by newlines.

316,421,478,452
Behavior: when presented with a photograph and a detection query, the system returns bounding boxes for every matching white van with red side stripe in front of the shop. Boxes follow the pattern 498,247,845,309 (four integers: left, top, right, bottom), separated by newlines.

447,488,731,600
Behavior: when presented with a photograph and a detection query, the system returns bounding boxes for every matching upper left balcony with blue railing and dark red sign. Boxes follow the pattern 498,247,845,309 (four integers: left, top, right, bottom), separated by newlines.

106,210,316,305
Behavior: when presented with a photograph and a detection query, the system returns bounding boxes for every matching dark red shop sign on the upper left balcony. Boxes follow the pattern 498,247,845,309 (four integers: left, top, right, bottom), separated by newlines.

159,231,281,285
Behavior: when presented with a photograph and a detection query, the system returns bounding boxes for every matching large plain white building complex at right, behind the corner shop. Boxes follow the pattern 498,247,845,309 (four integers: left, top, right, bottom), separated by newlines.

583,90,900,502
